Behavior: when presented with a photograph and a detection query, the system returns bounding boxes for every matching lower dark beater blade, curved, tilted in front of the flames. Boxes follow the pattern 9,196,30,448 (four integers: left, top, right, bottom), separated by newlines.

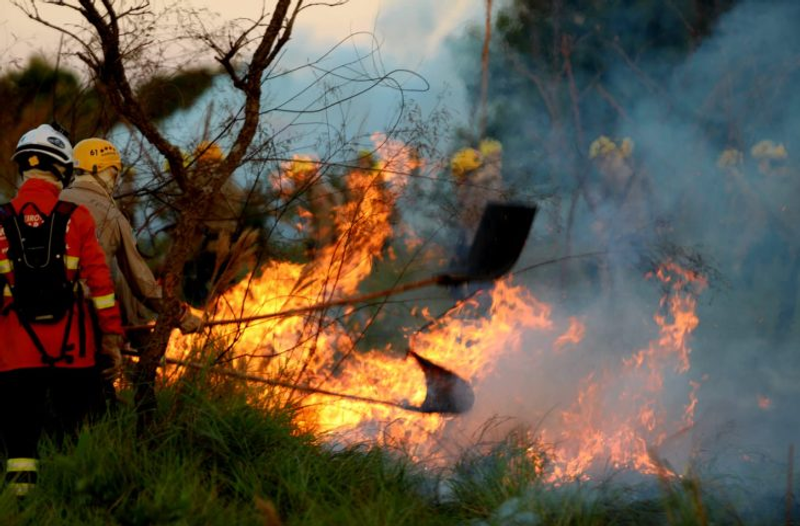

408,350,475,414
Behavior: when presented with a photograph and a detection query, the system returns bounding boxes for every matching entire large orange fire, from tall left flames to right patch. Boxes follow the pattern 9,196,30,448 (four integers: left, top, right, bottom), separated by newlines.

168,136,705,480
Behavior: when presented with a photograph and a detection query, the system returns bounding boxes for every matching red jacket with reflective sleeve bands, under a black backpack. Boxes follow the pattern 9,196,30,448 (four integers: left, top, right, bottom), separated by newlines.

0,179,122,372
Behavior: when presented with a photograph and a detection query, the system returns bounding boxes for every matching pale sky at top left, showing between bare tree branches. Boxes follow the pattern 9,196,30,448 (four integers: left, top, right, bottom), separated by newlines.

0,0,484,140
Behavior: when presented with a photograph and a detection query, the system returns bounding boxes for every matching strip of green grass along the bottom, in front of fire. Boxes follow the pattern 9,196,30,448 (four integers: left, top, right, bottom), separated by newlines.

0,379,788,526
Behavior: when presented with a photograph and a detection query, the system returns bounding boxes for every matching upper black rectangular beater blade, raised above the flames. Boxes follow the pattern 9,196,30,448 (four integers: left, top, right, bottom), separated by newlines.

439,203,537,284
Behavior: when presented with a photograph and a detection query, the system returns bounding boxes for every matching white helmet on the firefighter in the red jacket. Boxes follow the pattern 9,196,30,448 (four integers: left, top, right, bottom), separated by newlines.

11,124,73,187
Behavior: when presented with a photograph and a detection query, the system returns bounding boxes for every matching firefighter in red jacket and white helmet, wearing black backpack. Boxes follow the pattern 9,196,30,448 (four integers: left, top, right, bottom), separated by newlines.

0,125,122,495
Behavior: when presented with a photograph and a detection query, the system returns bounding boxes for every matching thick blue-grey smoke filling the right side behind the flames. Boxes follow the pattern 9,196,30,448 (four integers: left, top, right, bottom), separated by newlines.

438,0,800,510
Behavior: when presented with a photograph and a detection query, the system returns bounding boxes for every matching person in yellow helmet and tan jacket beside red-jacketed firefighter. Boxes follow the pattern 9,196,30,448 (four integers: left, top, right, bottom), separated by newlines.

61,137,202,360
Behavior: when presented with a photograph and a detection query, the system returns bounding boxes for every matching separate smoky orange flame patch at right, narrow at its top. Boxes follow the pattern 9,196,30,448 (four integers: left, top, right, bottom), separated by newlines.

552,262,706,480
